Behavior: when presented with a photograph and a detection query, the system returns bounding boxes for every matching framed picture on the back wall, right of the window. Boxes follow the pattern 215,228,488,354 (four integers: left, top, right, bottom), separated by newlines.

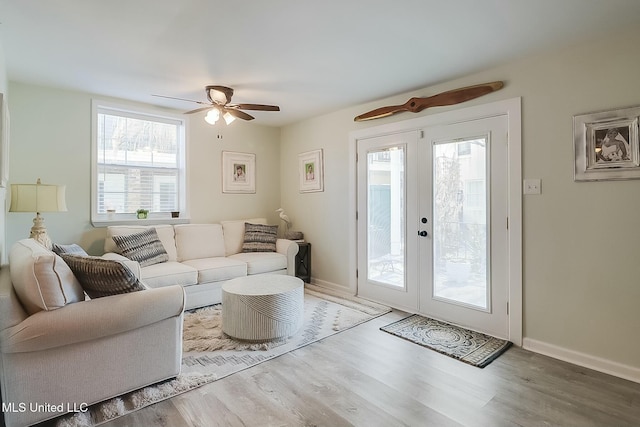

222,151,256,193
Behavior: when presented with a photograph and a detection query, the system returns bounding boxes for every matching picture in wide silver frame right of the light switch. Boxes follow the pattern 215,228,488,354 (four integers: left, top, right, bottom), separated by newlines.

573,107,640,181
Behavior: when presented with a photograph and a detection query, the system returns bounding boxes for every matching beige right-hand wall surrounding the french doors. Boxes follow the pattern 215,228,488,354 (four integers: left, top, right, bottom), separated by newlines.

280,25,640,379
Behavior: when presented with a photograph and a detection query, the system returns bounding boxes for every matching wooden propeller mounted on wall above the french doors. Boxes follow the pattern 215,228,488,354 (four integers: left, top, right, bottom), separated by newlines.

353,81,504,122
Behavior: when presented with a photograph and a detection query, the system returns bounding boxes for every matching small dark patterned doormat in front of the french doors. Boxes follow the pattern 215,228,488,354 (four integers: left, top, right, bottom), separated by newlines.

380,314,511,368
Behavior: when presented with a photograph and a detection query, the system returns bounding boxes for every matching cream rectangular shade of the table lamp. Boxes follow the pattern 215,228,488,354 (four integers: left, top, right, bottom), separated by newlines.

9,184,67,212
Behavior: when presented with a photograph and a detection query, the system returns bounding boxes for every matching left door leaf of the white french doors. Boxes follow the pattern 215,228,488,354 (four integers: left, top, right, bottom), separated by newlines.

357,131,419,311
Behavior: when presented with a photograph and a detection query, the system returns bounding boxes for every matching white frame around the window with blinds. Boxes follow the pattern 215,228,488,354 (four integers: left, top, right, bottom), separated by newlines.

91,99,189,227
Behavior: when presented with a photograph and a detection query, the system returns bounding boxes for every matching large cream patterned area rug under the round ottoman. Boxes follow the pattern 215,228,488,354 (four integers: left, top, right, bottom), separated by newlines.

53,284,391,427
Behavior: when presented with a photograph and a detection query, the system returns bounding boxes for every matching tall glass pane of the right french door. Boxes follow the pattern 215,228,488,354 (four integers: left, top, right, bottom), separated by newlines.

433,138,489,309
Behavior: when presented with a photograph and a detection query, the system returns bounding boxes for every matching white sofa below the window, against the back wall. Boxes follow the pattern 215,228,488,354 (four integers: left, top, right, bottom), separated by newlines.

103,218,299,310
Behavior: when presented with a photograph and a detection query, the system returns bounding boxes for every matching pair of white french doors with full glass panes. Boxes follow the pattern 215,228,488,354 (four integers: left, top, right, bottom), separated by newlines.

357,116,508,337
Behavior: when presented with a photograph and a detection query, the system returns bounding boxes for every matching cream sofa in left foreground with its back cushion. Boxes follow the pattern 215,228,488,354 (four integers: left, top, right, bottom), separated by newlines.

0,239,184,427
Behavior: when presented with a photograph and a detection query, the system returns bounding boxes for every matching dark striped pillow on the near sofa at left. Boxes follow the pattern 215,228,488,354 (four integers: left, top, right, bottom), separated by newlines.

62,254,146,298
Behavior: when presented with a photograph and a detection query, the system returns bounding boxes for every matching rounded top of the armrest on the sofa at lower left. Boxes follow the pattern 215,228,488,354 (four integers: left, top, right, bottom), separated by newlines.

0,285,185,353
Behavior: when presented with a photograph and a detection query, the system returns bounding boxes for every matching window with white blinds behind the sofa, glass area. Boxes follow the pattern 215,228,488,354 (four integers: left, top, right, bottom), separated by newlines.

91,101,186,222
